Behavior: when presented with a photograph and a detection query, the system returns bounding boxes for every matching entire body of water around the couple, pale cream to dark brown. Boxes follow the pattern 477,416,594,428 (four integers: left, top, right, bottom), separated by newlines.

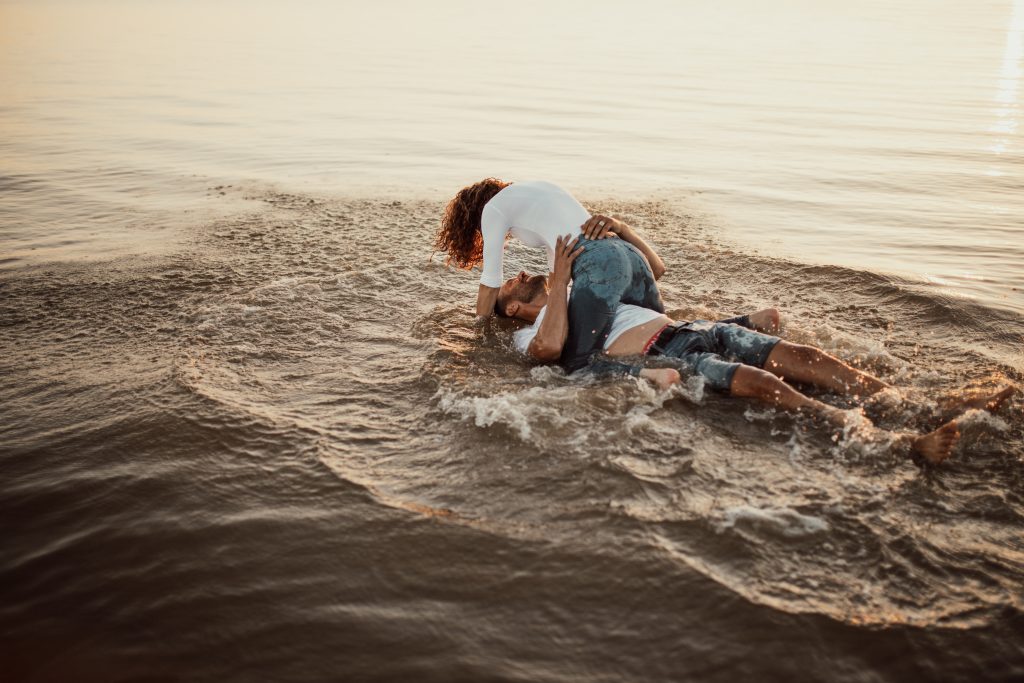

0,3,1024,681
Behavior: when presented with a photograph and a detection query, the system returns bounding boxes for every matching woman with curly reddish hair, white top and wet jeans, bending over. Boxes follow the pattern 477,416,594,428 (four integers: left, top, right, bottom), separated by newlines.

434,178,665,372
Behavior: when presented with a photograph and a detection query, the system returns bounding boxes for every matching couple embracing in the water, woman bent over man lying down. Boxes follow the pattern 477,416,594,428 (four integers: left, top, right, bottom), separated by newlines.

435,178,1013,463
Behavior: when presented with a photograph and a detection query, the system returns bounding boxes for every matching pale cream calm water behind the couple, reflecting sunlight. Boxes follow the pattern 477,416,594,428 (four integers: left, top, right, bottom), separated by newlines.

0,0,1024,312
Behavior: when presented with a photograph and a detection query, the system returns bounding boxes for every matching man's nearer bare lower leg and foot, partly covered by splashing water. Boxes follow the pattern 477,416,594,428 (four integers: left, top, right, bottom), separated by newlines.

729,368,959,464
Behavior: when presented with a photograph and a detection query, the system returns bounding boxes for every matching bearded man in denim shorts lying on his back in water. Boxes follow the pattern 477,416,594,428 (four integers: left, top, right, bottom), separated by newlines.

498,216,1013,463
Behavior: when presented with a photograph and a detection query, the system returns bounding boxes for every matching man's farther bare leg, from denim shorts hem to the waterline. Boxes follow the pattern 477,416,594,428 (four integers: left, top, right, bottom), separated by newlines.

765,341,890,396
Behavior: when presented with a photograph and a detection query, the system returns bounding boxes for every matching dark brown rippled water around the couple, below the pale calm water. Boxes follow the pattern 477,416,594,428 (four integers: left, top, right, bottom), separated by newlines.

0,189,1024,682
